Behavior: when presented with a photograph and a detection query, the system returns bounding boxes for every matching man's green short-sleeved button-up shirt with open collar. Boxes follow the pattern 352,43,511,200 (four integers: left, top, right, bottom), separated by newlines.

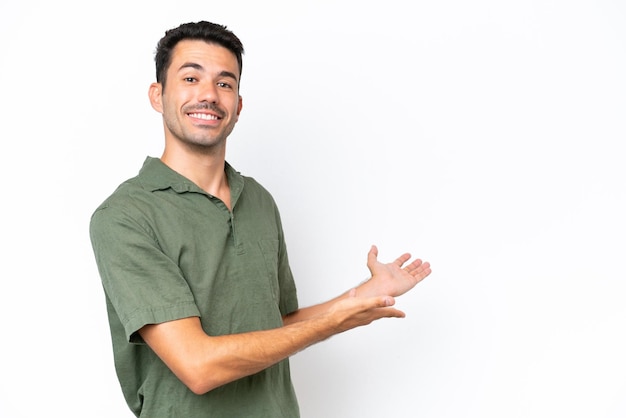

90,157,299,418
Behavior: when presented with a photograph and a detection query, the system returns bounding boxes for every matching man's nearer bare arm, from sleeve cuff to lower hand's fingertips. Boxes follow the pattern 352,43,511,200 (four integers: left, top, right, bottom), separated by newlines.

139,291,404,394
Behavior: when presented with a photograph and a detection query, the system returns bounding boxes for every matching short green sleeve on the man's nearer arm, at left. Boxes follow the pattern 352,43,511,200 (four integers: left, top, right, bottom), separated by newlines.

89,205,200,342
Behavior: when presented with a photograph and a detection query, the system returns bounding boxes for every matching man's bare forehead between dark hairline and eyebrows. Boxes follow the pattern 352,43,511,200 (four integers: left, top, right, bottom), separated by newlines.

168,40,239,75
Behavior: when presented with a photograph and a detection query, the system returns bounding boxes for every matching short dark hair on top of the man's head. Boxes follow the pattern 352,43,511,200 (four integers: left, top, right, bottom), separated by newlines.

154,21,243,87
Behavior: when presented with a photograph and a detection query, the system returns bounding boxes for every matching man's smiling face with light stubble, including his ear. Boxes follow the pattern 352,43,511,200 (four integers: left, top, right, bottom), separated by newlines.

150,40,242,149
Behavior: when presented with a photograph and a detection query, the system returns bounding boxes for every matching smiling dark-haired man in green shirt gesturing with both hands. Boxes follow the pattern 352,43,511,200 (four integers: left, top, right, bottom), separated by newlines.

90,22,430,418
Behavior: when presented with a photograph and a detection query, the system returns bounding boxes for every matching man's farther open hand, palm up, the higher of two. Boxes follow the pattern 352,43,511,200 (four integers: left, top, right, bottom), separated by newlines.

358,245,431,297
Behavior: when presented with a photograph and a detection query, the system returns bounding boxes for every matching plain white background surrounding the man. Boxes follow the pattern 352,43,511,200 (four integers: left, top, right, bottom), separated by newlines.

0,0,626,418
